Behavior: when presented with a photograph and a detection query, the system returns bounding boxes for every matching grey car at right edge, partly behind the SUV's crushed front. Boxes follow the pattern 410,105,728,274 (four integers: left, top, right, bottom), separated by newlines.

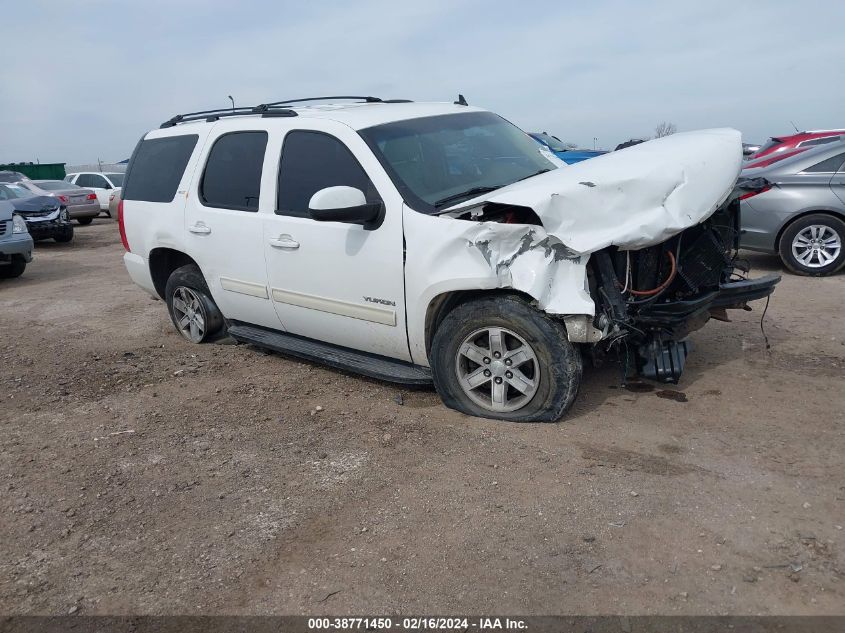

740,142,845,276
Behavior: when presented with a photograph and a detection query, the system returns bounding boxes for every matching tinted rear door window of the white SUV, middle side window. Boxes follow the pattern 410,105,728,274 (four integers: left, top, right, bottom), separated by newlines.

200,132,267,211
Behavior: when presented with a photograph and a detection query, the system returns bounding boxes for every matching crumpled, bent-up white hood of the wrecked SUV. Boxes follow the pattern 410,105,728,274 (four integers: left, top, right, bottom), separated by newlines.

447,128,742,253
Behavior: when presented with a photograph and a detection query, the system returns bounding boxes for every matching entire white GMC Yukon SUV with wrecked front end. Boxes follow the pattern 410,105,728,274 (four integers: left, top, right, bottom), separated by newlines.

118,97,779,421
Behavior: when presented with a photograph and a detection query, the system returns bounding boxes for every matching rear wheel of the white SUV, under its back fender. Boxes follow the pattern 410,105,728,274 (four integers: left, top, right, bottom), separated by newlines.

164,264,224,343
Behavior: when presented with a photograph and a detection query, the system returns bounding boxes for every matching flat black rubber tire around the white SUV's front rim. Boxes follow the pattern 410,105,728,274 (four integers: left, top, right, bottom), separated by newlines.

430,295,582,422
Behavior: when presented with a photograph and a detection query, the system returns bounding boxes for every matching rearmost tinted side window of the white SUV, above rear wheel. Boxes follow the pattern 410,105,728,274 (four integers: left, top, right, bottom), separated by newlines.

122,134,199,202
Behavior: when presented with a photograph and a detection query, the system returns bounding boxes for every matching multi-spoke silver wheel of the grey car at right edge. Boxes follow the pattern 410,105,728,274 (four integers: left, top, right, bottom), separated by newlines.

780,213,845,276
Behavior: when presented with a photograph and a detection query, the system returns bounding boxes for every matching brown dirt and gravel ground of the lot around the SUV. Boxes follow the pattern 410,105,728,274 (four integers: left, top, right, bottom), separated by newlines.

0,219,845,615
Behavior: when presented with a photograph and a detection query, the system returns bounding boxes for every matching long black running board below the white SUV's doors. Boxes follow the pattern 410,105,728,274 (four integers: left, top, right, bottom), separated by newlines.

229,323,432,385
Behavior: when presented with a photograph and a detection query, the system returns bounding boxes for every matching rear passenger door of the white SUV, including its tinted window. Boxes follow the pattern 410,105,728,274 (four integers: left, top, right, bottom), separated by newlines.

185,121,282,329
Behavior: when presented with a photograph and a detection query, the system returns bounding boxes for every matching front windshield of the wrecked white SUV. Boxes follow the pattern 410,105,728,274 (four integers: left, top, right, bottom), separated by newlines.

359,112,558,213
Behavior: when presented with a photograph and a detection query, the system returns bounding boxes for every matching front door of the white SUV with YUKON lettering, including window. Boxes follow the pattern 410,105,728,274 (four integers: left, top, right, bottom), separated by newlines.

264,122,410,360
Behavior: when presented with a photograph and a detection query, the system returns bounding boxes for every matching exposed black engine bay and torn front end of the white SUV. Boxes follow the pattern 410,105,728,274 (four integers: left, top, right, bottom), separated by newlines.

588,195,780,383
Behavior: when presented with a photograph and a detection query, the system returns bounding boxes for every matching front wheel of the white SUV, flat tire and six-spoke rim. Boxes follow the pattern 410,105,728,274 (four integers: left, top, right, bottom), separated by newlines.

431,296,582,422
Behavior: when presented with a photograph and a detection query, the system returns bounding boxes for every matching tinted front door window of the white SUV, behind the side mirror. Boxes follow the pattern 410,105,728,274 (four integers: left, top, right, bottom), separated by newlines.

276,130,381,218
